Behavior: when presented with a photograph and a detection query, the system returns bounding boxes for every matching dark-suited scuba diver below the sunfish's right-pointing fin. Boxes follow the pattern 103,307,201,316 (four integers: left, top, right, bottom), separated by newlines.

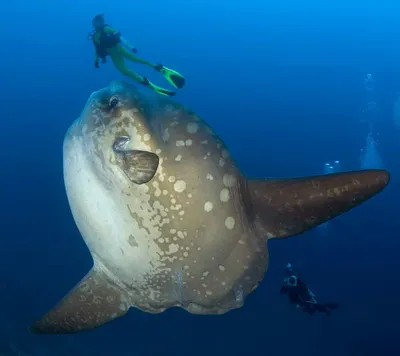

281,263,339,315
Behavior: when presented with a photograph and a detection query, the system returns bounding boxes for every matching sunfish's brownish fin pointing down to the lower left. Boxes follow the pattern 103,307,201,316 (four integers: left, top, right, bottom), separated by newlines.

30,267,129,334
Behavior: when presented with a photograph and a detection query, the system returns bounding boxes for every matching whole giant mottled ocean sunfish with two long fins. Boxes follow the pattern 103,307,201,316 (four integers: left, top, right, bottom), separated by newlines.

31,82,389,333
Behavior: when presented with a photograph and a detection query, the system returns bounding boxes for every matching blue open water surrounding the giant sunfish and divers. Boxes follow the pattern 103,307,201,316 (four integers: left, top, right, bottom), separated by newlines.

0,0,400,356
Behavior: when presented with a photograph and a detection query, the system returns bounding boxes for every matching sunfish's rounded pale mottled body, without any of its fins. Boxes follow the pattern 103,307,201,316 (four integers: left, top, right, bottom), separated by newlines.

64,83,267,314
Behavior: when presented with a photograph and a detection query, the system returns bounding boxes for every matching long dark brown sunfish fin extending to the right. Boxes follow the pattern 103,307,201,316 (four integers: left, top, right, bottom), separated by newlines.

248,170,389,238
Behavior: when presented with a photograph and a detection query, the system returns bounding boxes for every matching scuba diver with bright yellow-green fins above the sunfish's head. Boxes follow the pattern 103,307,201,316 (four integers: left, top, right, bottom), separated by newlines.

88,14,185,96
